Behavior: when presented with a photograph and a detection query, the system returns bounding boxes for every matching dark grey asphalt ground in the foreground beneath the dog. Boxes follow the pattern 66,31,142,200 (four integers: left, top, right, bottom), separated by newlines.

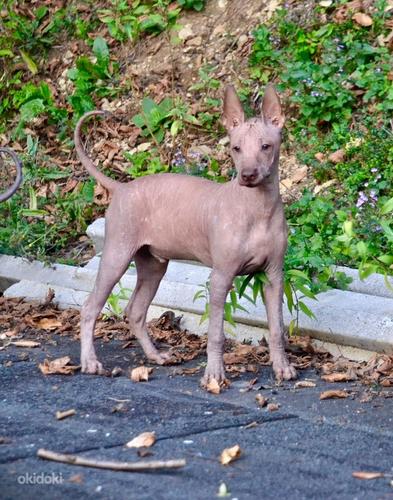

0,337,393,500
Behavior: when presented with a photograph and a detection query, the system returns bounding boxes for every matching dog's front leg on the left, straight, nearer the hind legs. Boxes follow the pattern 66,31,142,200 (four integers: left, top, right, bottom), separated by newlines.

202,269,234,385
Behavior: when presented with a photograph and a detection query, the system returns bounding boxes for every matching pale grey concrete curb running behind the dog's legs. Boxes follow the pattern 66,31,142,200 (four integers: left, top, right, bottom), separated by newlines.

0,256,393,360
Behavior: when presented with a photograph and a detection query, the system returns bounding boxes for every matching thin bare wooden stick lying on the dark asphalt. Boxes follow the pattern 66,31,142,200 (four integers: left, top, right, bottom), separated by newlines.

37,448,186,472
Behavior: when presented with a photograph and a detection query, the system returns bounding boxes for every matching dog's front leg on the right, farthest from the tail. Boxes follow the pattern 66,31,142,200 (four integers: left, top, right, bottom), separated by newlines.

264,270,296,380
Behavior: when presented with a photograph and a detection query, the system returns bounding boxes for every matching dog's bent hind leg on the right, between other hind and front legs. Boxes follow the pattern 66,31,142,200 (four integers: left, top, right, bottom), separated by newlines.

126,247,170,365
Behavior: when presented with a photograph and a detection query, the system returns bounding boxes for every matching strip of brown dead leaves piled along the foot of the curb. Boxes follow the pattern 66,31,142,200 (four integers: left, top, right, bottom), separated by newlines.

0,295,393,393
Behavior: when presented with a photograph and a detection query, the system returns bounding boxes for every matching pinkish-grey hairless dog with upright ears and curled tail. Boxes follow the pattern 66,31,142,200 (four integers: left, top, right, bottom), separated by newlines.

75,86,296,384
